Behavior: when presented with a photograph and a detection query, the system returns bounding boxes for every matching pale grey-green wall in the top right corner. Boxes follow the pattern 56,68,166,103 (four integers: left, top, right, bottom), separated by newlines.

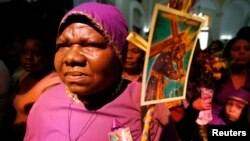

197,0,250,40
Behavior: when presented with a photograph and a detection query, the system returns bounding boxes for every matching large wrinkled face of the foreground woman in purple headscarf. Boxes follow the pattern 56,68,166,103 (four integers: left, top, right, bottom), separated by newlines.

54,23,119,95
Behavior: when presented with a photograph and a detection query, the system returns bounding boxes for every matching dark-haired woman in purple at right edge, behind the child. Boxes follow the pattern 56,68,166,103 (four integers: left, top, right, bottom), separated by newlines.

209,37,250,125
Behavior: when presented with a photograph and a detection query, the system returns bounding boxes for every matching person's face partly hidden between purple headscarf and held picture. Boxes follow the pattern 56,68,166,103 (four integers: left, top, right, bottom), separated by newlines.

122,42,145,82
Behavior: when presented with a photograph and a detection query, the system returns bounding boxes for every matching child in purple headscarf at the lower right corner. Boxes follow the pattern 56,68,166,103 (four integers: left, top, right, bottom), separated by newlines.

207,86,250,141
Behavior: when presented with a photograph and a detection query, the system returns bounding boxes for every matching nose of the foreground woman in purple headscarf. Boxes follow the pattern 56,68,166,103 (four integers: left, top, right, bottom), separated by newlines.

64,46,86,66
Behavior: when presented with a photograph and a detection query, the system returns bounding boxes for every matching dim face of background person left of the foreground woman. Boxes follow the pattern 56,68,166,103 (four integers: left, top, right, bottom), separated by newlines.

20,39,49,73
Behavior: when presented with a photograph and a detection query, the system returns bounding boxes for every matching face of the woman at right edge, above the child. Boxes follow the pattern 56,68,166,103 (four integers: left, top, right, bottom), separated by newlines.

230,39,250,65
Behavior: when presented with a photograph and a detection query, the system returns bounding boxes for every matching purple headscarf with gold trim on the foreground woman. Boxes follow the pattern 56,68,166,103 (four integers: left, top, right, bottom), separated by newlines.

58,2,128,62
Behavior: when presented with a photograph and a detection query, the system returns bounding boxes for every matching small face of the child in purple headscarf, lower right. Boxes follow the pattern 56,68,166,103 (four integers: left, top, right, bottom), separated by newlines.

226,99,245,122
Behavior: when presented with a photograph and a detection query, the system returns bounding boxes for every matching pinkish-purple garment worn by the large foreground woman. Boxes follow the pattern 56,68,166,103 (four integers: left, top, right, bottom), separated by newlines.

24,82,162,141
